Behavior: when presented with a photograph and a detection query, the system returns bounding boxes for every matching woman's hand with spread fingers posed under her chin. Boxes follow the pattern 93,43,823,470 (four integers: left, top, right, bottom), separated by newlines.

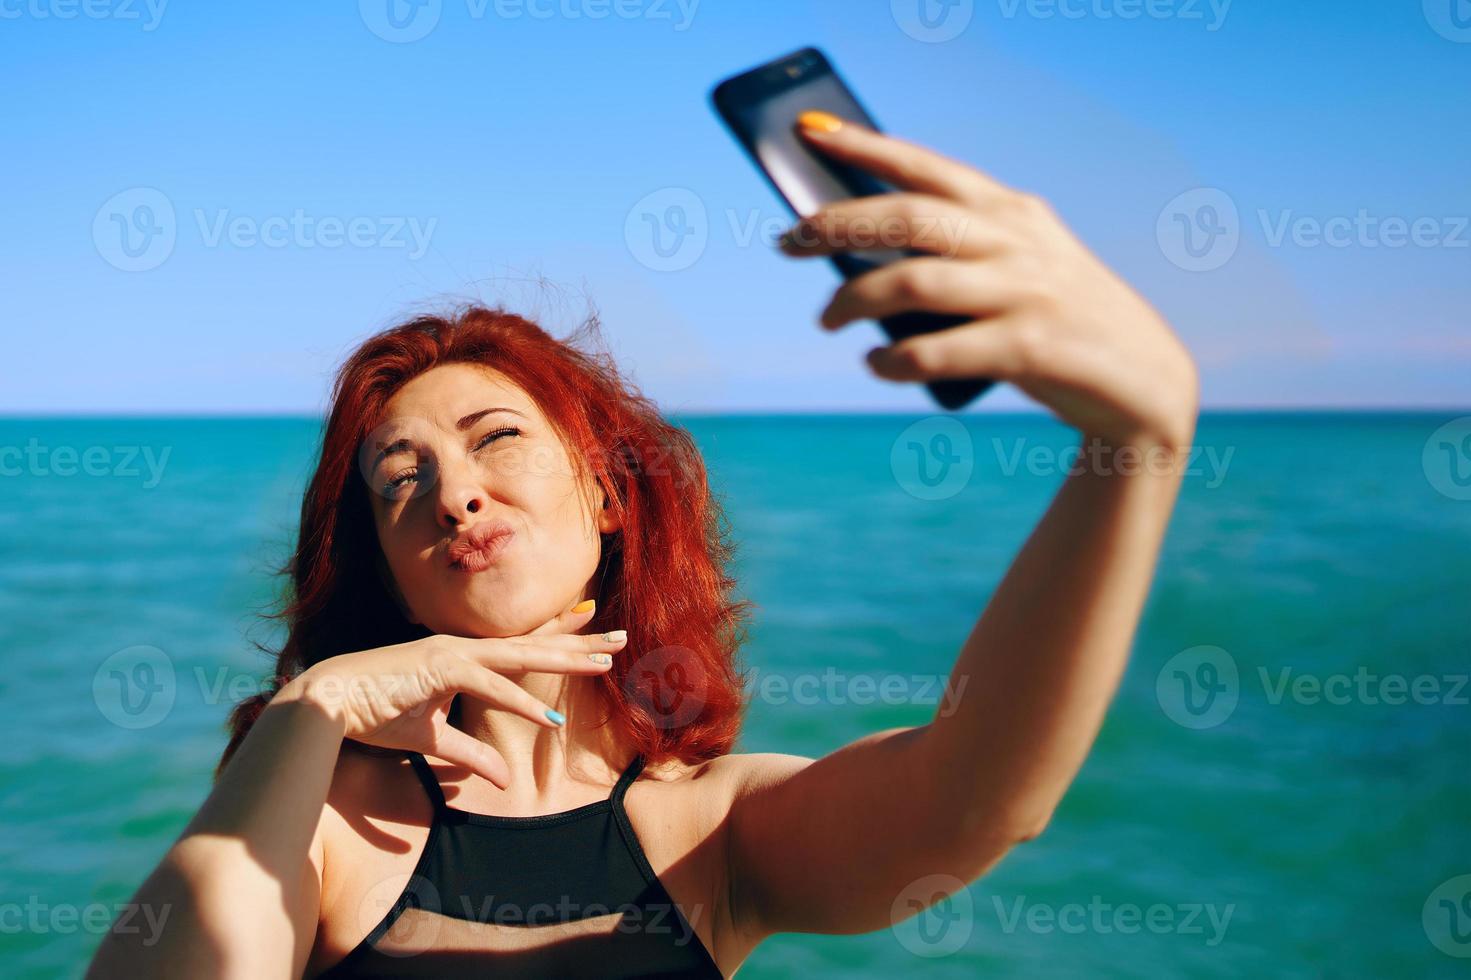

272,606,628,789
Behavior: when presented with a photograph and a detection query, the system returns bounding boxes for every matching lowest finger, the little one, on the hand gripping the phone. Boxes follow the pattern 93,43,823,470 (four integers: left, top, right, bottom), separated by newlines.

866,319,1036,381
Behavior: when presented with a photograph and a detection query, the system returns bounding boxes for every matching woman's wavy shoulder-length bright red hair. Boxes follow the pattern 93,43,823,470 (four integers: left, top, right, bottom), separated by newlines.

215,306,750,778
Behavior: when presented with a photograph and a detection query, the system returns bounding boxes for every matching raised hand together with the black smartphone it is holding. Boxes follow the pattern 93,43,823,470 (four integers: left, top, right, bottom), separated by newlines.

716,50,1200,450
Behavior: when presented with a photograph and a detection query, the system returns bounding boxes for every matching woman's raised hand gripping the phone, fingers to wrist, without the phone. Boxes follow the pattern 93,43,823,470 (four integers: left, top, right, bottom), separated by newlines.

781,113,1197,449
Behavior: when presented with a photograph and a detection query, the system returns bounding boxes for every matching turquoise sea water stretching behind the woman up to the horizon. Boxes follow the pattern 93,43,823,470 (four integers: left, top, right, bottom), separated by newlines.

0,412,1471,977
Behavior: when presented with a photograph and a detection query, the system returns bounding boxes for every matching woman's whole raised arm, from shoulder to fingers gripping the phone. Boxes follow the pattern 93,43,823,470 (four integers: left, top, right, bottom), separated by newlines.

717,116,1197,945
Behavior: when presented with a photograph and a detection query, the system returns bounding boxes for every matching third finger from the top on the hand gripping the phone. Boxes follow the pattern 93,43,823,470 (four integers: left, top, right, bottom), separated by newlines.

818,256,1019,330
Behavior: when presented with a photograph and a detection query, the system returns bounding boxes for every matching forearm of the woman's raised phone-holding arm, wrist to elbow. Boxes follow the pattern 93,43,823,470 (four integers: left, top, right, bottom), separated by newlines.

927,435,1183,840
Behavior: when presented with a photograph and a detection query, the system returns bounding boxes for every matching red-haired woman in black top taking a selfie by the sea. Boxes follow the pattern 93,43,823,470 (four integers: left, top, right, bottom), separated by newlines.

91,113,1197,977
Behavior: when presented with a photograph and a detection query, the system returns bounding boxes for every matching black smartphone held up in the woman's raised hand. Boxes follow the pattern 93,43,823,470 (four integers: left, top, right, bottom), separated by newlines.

710,47,993,411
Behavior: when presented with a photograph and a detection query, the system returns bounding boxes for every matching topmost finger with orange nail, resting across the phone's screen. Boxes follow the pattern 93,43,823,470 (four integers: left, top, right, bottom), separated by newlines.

797,112,1014,203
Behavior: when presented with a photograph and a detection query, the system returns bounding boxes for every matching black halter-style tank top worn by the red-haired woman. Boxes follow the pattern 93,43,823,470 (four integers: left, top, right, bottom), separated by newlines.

322,752,721,980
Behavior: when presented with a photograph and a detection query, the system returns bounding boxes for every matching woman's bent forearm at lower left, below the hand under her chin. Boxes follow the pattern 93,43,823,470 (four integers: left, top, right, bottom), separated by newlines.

87,684,343,977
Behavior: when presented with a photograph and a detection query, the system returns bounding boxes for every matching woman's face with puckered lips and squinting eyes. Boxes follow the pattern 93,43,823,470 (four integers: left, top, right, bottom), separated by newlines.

359,363,618,637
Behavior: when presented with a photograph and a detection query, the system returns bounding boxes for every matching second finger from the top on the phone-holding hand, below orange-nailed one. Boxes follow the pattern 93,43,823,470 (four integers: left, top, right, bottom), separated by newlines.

780,193,1011,259
